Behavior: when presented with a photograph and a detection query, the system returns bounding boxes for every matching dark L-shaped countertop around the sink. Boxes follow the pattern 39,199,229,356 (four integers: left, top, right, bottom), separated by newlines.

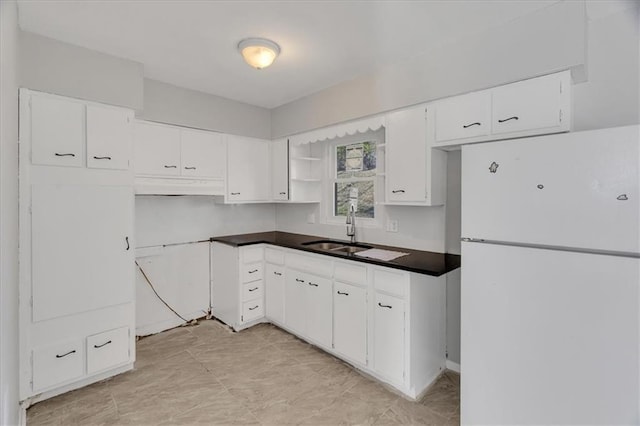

211,231,460,277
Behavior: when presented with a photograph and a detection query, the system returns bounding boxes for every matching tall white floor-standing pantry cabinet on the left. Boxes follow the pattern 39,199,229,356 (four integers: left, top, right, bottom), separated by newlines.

19,89,135,402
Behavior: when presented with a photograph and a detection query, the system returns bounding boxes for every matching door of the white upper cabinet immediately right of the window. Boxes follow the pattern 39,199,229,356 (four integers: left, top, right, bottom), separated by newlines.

386,107,426,202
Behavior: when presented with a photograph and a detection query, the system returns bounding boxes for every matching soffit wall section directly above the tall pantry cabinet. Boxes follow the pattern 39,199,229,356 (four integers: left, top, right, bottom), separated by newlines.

19,31,143,110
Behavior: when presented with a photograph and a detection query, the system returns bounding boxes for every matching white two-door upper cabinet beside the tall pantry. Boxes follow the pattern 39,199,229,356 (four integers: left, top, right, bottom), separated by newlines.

134,121,227,195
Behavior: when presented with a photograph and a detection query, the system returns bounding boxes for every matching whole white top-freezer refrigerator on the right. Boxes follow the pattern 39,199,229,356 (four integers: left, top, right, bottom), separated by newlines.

461,126,640,425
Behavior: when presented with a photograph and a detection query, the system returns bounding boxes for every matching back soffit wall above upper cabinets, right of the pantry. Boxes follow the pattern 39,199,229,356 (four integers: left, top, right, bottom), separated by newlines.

138,79,271,139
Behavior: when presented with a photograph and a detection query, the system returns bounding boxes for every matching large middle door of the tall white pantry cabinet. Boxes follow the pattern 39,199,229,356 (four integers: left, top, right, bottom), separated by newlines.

31,185,135,322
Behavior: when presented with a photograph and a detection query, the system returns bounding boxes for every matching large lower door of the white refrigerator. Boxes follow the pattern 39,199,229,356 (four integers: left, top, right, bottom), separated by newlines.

461,242,640,425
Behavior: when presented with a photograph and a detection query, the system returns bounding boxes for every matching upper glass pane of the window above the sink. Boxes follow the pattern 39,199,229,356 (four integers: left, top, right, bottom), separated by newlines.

336,142,376,179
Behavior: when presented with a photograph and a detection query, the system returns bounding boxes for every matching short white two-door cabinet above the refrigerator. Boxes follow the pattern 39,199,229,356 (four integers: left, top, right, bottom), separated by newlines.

429,71,571,147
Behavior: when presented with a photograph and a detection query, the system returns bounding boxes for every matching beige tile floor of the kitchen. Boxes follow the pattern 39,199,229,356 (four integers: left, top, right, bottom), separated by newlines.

27,321,460,426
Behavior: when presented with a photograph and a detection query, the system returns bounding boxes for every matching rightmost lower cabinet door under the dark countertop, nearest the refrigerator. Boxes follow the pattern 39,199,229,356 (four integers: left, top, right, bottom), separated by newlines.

373,293,404,383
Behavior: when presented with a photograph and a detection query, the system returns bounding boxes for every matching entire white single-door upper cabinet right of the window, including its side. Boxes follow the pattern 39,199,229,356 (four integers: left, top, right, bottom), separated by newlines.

385,105,446,206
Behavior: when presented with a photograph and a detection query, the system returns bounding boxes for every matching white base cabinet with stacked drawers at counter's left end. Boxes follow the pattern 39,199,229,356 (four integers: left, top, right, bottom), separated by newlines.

211,242,265,330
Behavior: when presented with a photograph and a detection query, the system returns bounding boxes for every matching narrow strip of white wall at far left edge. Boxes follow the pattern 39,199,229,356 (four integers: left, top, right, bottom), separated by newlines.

0,0,19,425
